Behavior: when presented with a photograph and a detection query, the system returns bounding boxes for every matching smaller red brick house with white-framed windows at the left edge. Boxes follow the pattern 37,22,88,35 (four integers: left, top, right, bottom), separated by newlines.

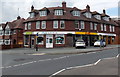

0,16,25,49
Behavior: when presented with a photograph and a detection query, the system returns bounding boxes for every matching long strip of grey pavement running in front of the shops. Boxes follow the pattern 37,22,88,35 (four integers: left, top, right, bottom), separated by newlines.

0,45,120,55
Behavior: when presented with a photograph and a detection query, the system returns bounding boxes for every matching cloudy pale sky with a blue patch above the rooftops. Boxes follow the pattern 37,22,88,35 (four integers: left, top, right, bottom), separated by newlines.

0,0,120,23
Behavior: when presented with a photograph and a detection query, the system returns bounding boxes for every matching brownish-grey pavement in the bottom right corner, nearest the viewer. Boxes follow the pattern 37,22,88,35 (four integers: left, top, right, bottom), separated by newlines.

57,58,118,75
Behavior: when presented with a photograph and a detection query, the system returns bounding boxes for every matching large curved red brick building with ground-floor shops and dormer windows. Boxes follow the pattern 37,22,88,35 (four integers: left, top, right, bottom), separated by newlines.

23,2,119,48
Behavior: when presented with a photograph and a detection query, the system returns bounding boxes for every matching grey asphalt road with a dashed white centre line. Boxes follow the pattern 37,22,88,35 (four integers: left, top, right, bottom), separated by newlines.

2,48,118,75
